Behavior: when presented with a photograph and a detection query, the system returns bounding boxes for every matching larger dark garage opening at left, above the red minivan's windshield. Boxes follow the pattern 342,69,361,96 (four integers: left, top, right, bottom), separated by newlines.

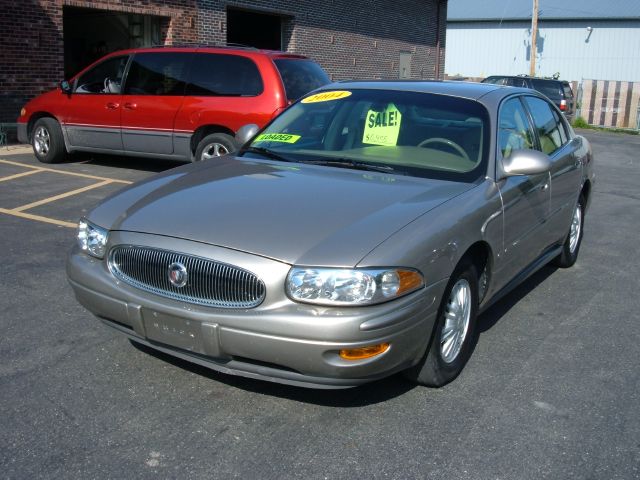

62,6,169,78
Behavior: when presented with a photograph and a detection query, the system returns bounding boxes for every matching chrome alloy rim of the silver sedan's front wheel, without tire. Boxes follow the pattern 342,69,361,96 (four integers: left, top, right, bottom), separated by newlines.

440,278,472,363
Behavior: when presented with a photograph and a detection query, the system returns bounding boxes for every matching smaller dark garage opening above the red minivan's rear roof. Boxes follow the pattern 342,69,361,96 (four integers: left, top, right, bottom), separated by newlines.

227,8,282,50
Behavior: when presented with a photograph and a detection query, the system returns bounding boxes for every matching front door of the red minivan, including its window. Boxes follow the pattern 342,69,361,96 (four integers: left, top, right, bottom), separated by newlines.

60,55,129,152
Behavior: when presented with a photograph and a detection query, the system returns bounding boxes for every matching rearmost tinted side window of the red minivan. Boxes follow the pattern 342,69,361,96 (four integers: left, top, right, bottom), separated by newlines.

186,53,264,97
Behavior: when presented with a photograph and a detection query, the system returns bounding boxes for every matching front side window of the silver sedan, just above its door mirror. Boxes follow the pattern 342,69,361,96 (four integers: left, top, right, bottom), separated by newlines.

498,98,534,158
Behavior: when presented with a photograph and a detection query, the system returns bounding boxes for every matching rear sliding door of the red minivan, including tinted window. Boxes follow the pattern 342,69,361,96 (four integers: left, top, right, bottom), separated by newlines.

121,52,192,155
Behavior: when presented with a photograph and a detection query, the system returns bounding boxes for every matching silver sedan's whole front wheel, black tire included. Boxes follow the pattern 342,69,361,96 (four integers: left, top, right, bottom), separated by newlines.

404,259,478,387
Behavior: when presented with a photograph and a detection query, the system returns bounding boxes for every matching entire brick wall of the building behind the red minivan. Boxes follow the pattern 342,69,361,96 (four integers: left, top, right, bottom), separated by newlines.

0,0,447,122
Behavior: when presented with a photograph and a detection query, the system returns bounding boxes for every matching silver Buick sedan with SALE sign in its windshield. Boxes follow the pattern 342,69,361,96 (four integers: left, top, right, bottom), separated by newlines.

67,82,594,388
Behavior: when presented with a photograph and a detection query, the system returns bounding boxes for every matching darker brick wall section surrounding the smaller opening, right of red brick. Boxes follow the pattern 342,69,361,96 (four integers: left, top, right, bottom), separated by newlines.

198,0,447,80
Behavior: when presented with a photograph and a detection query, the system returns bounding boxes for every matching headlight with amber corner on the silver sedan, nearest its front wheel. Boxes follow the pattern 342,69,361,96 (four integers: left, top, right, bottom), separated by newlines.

287,267,424,305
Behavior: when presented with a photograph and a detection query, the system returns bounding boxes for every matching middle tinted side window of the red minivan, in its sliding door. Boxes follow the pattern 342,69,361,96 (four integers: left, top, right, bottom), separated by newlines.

124,52,190,95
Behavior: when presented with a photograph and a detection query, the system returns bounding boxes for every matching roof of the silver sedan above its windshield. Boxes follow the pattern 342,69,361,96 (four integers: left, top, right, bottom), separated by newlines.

319,80,502,100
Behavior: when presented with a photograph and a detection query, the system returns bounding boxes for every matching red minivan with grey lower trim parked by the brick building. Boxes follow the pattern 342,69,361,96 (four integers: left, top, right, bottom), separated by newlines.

18,47,329,163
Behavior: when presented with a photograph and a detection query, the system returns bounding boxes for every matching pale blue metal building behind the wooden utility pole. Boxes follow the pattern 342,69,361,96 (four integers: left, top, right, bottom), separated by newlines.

445,0,640,82
